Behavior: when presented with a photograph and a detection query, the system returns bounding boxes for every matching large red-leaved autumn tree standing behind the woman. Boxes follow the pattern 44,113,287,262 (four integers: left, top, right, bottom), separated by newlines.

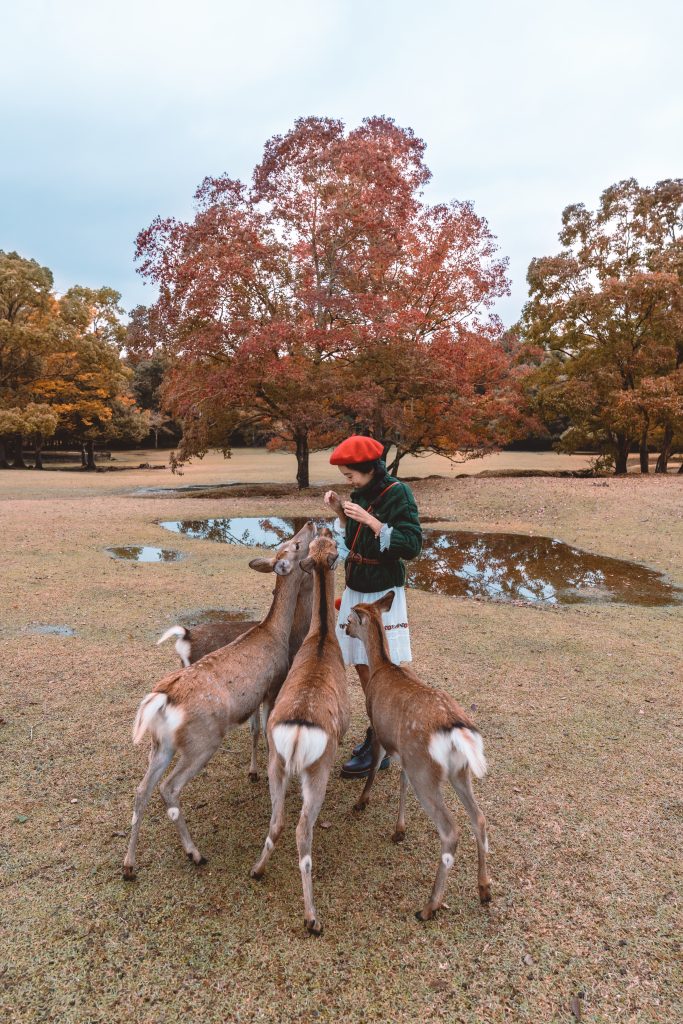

137,118,524,486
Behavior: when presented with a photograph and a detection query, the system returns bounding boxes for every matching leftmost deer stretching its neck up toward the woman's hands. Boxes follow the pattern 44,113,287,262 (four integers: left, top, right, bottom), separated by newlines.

123,522,316,881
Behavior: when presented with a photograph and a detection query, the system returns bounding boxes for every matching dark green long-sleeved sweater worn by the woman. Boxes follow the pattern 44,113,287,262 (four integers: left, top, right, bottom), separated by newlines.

344,473,422,594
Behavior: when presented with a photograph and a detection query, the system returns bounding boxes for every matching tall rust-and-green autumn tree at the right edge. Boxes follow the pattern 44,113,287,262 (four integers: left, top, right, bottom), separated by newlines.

522,179,683,474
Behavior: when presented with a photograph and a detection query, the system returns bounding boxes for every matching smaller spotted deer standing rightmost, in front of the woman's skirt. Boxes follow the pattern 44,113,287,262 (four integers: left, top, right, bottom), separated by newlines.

346,591,490,921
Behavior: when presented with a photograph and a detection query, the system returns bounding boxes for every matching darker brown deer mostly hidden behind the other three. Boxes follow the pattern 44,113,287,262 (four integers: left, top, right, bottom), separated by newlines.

157,572,313,782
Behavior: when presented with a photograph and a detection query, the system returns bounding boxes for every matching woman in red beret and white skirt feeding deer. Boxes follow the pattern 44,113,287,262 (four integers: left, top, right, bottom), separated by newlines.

325,436,422,778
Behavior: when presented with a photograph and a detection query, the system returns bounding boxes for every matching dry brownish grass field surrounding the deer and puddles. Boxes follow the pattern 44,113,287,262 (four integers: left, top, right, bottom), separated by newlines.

0,453,683,1024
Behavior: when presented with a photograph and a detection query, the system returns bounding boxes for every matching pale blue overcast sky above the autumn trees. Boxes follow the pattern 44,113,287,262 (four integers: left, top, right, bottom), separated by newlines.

0,0,683,323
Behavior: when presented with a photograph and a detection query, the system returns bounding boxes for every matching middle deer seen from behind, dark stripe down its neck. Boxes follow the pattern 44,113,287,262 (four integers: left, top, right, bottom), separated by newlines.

250,528,350,935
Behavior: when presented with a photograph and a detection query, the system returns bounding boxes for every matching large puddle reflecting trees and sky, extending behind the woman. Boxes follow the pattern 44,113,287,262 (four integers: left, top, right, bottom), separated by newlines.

160,516,683,605
